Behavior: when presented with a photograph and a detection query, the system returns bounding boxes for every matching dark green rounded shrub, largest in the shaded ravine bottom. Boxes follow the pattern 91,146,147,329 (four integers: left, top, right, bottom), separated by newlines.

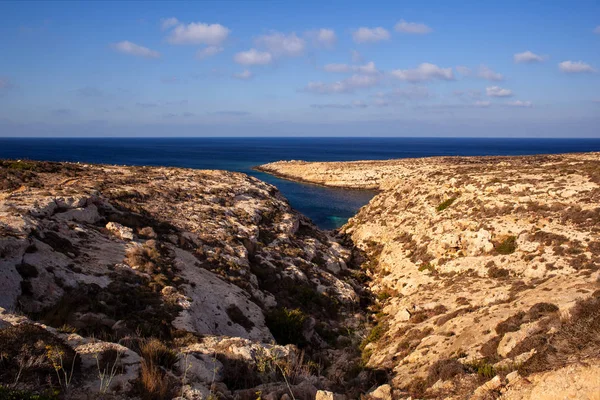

266,307,307,347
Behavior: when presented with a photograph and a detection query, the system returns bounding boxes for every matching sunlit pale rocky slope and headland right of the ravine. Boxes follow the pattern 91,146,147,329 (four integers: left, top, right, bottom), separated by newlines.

260,153,600,399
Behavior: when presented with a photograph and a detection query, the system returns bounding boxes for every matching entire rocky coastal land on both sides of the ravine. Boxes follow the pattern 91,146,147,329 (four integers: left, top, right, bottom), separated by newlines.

0,153,600,400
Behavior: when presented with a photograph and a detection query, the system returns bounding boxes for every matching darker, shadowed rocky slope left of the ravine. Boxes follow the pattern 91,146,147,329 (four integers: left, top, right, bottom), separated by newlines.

0,161,375,399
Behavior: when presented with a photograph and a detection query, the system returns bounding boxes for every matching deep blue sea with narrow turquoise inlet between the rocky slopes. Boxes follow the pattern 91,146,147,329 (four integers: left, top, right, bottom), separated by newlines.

0,138,600,229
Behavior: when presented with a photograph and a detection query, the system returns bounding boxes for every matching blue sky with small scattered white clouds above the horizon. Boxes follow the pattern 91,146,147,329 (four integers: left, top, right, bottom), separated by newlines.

0,0,600,137
